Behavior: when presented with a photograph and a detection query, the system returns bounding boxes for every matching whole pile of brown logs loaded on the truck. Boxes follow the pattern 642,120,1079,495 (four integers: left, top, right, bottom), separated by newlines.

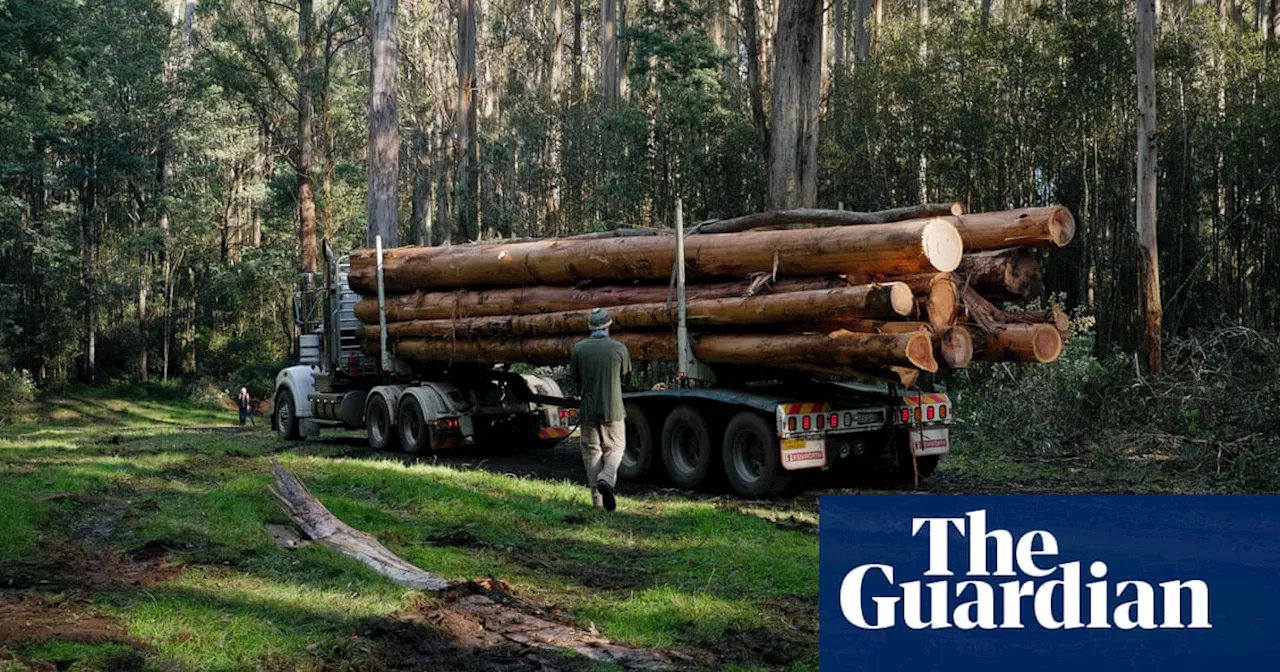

348,204,1075,384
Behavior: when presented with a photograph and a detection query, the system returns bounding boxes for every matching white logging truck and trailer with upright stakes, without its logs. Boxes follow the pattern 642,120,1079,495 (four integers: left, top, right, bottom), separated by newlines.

273,237,951,497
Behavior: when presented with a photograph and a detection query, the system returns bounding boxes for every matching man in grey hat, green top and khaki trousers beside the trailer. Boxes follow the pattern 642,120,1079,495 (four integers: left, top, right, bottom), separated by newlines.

568,308,631,511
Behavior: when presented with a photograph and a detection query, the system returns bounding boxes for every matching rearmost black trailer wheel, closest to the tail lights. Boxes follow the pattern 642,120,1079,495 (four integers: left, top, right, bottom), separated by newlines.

721,411,791,497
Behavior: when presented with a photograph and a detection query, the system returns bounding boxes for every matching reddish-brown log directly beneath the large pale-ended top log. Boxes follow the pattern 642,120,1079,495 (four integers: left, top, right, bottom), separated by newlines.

356,278,849,324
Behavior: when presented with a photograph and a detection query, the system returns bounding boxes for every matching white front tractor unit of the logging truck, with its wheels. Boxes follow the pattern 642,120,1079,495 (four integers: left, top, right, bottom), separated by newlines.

271,242,570,453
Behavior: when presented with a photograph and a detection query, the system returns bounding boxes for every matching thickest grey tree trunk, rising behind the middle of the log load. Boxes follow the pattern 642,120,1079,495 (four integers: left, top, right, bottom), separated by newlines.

769,0,823,210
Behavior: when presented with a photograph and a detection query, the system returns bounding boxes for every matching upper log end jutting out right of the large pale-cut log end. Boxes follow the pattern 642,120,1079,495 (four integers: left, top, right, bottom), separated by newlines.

940,205,1075,249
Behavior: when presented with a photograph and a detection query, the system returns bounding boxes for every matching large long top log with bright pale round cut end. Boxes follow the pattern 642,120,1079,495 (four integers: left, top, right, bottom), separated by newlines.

349,218,963,294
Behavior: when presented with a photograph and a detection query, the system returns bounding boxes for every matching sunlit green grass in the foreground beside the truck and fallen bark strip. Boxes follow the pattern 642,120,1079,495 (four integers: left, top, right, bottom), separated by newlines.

0,394,818,669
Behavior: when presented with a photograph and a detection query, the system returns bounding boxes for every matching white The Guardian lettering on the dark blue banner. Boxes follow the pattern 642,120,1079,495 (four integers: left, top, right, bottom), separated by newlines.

840,509,1213,630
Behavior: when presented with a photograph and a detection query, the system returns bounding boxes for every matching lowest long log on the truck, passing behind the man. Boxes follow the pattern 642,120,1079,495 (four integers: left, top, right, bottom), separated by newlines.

365,330,938,372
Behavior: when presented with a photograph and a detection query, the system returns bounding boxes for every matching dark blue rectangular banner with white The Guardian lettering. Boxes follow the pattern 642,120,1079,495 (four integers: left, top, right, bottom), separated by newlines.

819,495,1280,672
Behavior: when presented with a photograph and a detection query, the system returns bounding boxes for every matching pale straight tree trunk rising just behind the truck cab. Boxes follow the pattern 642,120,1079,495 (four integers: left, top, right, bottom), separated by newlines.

365,0,396,247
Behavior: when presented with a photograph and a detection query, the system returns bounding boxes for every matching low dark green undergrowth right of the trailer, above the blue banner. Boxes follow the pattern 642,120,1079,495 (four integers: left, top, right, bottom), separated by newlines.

951,322,1280,492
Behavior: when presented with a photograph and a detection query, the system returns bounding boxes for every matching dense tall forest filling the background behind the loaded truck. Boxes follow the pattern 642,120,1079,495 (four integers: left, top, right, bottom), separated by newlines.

0,0,1280,392
